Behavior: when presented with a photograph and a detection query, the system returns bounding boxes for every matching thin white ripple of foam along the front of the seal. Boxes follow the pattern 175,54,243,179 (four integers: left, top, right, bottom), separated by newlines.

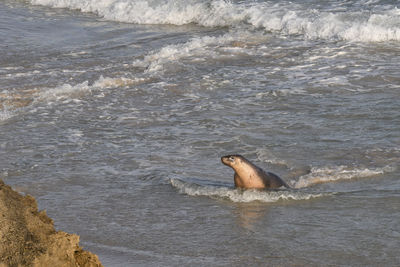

170,179,328,202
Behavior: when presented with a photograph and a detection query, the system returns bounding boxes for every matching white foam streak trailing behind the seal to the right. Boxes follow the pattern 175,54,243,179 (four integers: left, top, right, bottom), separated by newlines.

292,166,394,188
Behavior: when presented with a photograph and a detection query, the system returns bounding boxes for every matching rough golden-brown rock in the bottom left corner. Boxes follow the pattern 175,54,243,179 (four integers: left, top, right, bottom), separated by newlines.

0,180,102,267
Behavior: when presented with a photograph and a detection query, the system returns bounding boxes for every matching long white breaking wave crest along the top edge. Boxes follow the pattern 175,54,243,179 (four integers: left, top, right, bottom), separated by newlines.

31,0,400,42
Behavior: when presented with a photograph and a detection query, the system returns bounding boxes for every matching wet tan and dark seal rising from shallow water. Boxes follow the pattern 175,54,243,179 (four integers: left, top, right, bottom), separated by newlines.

221,155,290,191
